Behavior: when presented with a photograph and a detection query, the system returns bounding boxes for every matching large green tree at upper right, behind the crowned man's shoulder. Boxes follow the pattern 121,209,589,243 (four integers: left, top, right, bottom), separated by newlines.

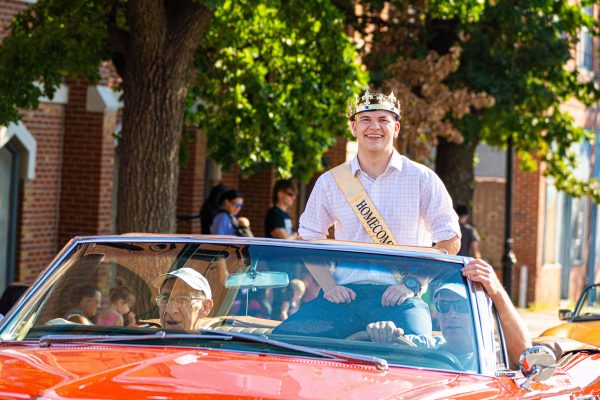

334,0,600,203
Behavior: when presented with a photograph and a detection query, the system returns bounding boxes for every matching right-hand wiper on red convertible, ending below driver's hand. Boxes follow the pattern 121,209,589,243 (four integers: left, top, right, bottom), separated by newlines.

200,329,388,371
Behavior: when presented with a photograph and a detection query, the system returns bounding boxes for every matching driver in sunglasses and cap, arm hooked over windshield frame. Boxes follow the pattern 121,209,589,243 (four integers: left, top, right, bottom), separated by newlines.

366,259,531,371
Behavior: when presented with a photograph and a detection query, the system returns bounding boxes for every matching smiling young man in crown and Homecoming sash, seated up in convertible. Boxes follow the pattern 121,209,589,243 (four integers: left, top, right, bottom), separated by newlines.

275,90,460,337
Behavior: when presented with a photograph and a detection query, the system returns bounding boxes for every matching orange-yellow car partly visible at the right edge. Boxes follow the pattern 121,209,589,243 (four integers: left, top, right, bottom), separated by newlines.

540,283,600,346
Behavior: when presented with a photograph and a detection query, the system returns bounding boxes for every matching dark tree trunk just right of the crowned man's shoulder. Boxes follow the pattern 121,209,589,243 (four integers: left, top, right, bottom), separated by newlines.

435,138,477,207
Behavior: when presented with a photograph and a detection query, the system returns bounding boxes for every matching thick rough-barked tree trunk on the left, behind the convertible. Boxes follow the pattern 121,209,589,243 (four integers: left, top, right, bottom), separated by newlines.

115,0,213,233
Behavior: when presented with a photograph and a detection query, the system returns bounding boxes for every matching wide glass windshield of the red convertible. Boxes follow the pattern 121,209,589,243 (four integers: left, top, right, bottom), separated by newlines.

0,239,479,372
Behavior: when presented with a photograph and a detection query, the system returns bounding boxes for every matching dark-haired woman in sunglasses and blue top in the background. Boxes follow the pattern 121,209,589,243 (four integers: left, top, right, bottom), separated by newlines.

210,189,254,237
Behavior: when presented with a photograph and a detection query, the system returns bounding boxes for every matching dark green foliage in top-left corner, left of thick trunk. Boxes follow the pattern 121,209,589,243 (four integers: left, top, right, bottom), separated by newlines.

0,0,111,123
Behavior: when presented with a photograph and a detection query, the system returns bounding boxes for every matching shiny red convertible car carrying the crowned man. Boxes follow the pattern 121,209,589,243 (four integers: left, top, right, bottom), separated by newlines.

0,235,600,399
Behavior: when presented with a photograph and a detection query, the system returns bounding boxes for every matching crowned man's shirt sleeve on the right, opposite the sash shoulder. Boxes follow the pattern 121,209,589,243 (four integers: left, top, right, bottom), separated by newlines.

420,170,461,243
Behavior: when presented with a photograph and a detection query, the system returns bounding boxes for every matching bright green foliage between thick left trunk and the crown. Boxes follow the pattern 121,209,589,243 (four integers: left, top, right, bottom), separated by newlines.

191,0,366,180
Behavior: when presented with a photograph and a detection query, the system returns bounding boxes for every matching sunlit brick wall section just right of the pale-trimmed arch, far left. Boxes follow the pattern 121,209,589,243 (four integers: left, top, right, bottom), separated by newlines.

15,104,65,283
